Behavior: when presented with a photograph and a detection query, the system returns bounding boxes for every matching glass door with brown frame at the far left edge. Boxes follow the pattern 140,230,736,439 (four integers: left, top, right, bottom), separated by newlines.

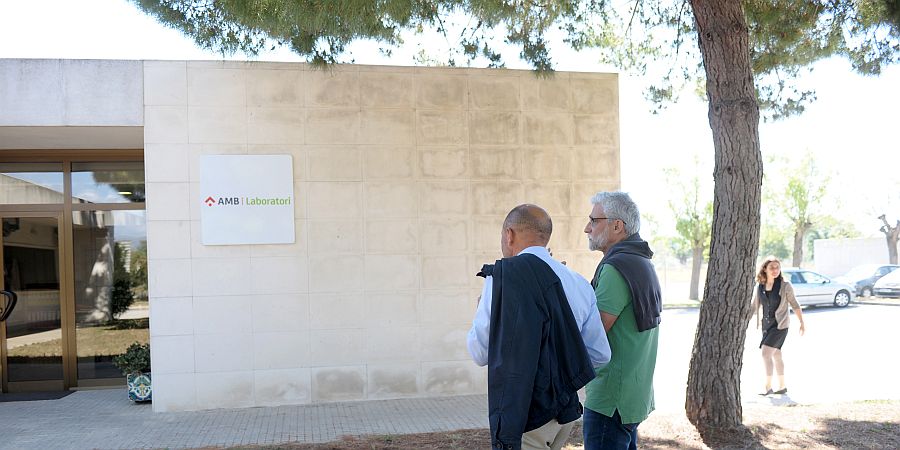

0,212,67,392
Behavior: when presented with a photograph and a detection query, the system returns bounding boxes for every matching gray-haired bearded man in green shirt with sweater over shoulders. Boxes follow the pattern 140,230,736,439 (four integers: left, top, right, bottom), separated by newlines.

583,192,662,450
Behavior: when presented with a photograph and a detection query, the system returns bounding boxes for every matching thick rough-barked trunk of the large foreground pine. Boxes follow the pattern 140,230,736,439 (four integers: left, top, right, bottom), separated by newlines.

685,0,762,435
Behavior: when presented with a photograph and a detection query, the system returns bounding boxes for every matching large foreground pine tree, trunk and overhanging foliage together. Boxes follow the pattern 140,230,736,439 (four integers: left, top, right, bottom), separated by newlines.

133,0,900,433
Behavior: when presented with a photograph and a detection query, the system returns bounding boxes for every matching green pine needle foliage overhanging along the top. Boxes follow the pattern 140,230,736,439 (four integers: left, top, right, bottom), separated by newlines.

132,0,900,119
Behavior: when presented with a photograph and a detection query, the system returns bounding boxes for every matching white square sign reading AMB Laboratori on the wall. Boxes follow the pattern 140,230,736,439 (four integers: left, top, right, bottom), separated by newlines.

200,155,294,245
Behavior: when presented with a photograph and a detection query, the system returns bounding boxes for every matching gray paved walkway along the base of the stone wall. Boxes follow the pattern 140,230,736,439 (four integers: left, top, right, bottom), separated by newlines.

0,389,488,450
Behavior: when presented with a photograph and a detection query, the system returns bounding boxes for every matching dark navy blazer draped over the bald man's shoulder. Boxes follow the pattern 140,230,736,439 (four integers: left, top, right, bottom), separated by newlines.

482,253,594,449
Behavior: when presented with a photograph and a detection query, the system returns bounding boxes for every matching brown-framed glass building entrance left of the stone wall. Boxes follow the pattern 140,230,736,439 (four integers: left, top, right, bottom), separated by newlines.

0,156,149,392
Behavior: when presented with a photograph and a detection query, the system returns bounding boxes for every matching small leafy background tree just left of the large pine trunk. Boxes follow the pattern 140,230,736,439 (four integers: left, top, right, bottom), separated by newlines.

666,167,713,300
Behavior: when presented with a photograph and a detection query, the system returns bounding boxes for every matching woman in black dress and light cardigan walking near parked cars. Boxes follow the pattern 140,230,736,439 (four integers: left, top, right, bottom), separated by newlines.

752,256,806,395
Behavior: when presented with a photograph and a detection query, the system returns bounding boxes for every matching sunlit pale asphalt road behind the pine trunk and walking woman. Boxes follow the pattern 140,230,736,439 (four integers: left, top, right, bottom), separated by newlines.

654,304,900,411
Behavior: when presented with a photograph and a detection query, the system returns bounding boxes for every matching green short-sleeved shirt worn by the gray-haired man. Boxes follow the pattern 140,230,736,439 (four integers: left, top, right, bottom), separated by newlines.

584,264,659,423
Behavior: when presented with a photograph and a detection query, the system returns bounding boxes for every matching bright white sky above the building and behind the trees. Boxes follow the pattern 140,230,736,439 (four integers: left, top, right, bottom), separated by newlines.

0,0,900,241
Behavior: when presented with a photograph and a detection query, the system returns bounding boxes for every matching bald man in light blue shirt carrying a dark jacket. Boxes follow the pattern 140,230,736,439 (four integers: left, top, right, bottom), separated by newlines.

467,204,610,449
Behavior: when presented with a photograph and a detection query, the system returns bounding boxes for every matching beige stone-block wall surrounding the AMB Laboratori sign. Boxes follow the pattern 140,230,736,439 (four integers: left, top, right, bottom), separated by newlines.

144,61,619,411
